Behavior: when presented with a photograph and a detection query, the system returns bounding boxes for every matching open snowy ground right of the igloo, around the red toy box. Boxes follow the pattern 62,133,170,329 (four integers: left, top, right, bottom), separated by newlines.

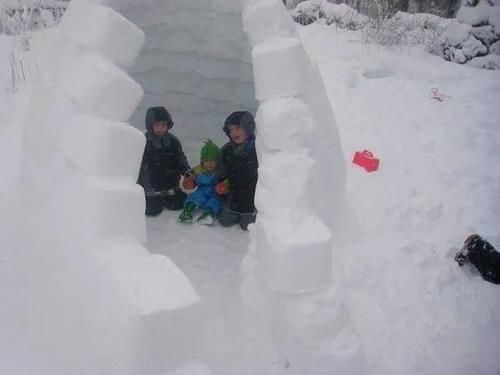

296,22,500,374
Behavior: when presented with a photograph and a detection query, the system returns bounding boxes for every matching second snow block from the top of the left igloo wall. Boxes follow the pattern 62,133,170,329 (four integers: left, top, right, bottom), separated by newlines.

59,54,143,121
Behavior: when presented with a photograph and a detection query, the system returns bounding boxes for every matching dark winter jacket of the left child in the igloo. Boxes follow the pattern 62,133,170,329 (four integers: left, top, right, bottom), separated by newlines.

138,132,190,192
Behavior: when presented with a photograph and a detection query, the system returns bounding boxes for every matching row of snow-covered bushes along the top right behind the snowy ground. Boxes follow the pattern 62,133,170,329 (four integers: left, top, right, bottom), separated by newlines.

291,0,500,69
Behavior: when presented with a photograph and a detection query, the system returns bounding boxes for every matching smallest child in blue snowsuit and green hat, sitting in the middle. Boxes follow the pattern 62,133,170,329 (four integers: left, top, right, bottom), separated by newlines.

179,139,222,225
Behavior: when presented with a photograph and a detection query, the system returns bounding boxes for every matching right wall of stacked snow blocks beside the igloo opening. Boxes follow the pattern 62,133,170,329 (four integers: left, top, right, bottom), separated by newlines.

243,0,351,294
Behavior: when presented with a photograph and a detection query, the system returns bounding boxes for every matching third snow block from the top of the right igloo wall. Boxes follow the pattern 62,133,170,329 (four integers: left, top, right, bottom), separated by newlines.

256,98,316,151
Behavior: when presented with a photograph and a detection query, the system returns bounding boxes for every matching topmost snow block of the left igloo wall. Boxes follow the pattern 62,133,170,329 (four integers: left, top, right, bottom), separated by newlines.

60,0,145,68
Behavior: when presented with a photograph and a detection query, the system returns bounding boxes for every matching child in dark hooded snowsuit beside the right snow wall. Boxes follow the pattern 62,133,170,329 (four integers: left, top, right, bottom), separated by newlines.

217,111,259,230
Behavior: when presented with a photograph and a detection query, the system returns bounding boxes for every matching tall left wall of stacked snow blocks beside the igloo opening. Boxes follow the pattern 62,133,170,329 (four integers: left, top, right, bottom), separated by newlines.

0,0,198,374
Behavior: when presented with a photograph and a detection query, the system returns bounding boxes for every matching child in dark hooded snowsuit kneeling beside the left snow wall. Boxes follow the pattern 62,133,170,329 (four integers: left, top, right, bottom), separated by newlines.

137,107,190,216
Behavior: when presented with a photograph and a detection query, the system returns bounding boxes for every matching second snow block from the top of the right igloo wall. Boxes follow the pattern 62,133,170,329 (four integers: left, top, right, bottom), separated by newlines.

252,38,308,101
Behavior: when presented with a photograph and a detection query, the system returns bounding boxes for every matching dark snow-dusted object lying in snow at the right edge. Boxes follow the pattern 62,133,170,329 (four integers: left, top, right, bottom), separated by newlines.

455,234,500,284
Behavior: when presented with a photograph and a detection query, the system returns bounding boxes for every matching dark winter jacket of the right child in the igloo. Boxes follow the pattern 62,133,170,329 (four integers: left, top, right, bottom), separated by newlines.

222,137,259,213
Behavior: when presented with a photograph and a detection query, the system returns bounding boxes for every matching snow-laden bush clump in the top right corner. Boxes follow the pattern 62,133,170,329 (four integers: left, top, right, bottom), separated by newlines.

440,3,500,69
